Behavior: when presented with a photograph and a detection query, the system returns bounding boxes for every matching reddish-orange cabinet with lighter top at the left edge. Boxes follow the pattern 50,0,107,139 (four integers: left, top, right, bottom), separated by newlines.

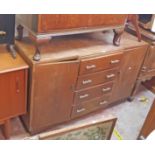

0,45,28,139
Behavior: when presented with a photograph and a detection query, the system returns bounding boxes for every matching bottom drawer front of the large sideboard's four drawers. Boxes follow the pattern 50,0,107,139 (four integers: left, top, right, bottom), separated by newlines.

71,94,111,118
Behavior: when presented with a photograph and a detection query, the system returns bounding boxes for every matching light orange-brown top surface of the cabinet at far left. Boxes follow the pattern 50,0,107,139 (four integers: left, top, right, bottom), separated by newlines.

0,45,28,74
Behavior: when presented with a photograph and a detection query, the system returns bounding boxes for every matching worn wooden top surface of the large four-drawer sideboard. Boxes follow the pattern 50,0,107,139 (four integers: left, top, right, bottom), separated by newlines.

16,31,148,64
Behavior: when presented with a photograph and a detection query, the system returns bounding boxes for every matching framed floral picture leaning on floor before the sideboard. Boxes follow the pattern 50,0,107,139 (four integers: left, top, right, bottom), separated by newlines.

39,117,117,140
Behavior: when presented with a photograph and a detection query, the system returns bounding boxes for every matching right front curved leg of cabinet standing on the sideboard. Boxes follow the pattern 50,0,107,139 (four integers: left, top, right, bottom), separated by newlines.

113,29,124,46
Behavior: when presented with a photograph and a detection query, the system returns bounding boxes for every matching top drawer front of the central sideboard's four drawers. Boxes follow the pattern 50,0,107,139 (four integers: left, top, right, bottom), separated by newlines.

79,52,123,75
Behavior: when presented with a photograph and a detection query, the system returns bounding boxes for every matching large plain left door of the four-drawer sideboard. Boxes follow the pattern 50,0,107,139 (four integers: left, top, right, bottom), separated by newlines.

30,61,79,132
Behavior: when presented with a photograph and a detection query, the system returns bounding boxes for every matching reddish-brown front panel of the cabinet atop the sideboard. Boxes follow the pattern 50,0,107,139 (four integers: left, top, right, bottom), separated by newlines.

38,14,127,33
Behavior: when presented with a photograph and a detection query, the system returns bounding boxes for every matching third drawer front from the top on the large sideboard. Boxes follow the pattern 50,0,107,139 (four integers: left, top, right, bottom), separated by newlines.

75,82,113,104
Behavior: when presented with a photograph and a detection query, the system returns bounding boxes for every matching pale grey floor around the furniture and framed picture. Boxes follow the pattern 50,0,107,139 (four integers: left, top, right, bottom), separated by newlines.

0,86,155,140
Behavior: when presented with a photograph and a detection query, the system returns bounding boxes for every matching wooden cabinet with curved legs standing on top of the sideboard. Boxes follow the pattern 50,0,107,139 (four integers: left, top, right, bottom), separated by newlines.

16,14,127,61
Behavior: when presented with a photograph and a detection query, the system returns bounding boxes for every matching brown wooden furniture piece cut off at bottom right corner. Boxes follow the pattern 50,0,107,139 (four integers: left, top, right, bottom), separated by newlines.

138,100,155,139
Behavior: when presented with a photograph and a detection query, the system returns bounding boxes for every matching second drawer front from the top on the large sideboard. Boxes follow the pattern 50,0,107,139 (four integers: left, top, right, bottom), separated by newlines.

76,68,119,89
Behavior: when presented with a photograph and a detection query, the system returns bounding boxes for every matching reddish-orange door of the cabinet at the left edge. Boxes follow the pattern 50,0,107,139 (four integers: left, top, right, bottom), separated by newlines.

0,70,27,120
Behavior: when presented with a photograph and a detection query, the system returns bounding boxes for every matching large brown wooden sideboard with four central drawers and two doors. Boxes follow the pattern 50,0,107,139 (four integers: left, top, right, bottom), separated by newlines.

16,31,148,134
